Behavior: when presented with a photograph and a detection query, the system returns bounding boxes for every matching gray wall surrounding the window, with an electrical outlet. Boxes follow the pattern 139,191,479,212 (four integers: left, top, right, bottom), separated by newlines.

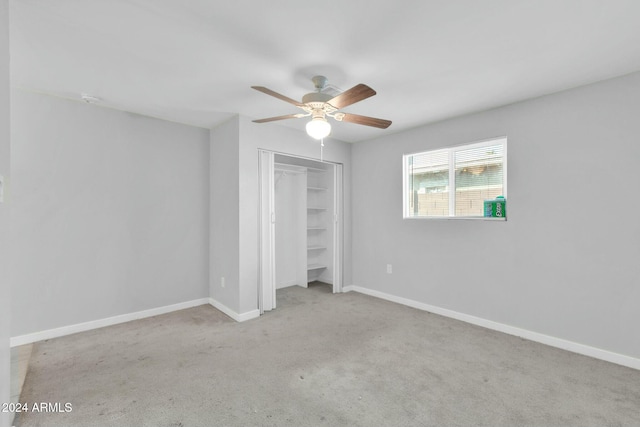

352,73,640,358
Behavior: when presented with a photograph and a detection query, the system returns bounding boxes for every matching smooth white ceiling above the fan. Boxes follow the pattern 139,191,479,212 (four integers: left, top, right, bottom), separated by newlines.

10,0,640,142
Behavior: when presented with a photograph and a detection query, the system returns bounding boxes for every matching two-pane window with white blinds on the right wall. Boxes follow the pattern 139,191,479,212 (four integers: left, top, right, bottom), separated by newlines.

403,138,507,218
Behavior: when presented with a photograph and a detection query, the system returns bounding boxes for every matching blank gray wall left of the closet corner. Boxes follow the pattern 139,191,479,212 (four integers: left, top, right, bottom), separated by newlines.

11,90,209,336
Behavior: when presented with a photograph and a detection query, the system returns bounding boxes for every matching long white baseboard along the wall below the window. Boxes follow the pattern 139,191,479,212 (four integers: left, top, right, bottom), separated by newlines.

342,285,640,370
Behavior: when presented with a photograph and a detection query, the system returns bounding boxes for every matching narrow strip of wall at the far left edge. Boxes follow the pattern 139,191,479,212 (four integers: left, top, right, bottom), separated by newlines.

0,0,11,427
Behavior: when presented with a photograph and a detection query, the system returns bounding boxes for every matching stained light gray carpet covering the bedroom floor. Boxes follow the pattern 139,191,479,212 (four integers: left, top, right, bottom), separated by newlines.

16,285,640,427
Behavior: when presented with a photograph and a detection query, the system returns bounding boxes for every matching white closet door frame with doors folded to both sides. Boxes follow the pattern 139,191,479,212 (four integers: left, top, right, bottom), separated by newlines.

258,149,344,314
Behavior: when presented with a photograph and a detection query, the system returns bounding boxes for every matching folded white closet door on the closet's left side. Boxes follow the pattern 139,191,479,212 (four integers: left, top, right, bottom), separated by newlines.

258,150,276,314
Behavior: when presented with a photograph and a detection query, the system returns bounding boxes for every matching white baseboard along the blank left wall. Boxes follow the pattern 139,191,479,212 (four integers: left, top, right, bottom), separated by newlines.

10,298,209,347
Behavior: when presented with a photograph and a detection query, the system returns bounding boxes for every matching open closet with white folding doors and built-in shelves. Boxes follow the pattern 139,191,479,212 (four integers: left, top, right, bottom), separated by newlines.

258,150,343,314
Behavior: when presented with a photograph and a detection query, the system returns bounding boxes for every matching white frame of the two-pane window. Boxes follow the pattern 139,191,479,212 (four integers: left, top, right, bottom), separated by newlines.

402,136,508,221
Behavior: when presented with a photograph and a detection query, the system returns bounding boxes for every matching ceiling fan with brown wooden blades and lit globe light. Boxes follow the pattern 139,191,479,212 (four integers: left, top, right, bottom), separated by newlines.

251,76,391,139
